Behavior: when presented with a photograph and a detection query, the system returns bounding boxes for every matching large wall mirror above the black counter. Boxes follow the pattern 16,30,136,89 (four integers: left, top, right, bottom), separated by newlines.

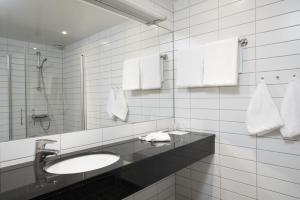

0,0,174,142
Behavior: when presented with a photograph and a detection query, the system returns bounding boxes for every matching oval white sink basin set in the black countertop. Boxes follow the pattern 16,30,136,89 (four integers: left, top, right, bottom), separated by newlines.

45,153,120,174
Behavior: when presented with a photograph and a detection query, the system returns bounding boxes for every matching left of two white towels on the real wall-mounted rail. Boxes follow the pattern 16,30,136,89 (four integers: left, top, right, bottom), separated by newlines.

176,46,204,88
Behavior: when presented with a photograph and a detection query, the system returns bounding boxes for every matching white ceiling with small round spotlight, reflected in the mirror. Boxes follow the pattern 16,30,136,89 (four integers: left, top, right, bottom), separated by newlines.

0,0,128,45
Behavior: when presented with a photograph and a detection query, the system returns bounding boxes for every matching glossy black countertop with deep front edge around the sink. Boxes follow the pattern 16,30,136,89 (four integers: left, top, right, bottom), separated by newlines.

0,132,215,200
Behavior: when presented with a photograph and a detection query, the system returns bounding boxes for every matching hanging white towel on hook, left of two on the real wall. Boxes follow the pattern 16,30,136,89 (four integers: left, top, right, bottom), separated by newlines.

246,81,283,135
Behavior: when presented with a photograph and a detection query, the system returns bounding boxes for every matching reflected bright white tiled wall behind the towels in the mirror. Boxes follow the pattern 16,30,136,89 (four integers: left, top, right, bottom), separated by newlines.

63,1,173,131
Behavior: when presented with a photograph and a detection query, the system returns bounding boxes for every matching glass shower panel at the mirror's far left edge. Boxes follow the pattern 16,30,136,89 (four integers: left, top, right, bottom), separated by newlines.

0,39,26,142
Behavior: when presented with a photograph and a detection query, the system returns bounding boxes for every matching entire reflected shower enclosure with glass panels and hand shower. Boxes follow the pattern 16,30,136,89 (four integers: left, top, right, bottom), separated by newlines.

0,42,86,142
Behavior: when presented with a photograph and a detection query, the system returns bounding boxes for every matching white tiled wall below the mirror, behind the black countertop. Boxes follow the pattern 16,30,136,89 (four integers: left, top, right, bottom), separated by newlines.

0,118,175,200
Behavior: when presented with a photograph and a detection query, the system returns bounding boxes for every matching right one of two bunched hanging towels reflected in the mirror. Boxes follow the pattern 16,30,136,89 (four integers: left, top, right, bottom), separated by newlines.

112,90,128,121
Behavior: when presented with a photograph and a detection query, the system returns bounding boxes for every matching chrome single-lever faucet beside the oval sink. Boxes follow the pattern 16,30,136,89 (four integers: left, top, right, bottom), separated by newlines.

35,139,59,163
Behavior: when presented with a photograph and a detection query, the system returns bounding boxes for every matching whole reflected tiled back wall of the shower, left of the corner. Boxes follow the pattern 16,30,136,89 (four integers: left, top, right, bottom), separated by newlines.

0,38,63,141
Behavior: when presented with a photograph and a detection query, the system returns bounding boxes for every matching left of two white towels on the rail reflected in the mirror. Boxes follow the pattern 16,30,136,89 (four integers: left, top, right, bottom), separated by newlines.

122,58,140,90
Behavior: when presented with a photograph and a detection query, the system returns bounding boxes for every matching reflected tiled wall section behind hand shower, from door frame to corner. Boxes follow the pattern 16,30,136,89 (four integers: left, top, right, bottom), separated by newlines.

26,43,63,137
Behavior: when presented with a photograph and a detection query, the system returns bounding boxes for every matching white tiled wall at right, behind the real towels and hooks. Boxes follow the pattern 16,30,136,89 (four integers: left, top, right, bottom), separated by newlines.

174,0,300,200
